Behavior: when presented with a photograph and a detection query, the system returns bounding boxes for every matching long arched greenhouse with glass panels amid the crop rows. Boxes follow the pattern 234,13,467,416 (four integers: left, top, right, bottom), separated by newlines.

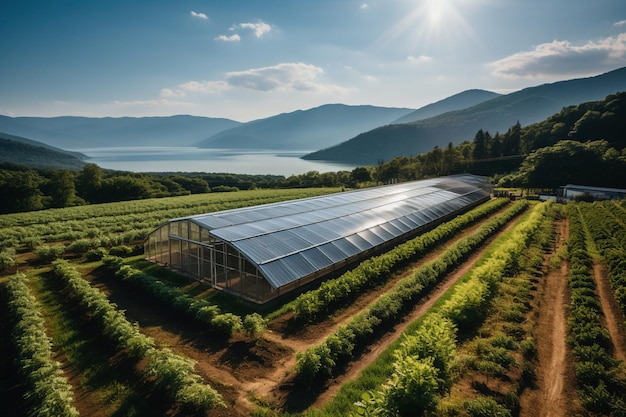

144,175,491,303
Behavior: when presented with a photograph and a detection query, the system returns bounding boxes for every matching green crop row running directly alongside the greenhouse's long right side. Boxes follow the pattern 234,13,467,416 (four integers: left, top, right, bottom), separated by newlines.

287,199,509,321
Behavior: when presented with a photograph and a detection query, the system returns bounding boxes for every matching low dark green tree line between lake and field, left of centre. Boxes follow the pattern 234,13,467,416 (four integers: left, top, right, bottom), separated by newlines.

0,163,358,214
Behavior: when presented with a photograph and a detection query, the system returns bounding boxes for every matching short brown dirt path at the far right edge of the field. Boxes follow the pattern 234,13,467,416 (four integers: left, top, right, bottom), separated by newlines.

593,261,626,361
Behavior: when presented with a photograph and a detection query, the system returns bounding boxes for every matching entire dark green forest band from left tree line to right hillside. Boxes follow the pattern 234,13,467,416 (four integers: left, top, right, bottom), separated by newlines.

0,92,626,213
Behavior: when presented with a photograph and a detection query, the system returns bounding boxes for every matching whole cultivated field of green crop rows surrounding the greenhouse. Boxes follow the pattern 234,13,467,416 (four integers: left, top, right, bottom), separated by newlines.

0,189,626,416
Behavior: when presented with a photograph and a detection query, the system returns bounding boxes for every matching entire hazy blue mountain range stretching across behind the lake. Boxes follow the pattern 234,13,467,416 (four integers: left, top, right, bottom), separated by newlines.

0,67,626,166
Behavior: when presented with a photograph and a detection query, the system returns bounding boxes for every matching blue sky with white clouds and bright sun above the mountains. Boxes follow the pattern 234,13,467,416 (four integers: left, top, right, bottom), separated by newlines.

0,0,626,121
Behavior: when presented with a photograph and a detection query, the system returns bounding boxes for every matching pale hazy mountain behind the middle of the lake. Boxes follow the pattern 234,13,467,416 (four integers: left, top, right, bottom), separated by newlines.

197,104,412,150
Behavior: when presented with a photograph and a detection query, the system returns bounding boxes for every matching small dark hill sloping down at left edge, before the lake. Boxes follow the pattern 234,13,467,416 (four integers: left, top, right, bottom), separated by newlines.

0,133,86,170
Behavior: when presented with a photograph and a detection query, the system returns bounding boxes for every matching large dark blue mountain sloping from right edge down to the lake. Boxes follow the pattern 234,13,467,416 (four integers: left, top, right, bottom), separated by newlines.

304,68,626,165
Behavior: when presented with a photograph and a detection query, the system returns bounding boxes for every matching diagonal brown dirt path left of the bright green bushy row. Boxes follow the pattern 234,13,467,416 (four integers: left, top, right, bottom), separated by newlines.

271,214,519,411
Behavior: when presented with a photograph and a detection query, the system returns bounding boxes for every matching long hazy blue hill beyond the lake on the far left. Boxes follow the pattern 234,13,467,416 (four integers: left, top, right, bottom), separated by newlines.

0,115,241,149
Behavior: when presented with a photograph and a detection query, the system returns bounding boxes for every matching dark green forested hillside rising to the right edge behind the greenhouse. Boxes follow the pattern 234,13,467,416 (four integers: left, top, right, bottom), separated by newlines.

375,93,626,188
